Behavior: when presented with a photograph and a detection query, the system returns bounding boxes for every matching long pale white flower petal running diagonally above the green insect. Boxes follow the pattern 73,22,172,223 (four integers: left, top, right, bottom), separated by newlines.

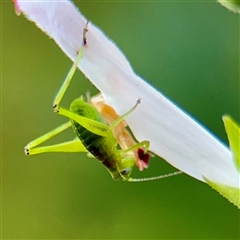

17,0,239,188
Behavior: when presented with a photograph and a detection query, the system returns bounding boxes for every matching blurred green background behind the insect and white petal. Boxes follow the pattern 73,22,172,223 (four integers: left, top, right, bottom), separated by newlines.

0,1,240,239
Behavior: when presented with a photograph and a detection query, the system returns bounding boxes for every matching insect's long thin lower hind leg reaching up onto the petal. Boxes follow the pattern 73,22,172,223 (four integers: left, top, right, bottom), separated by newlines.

53,22,88,112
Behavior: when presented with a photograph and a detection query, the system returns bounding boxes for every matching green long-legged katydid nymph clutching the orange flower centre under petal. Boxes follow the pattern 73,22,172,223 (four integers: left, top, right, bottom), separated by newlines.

25,22,180,182
